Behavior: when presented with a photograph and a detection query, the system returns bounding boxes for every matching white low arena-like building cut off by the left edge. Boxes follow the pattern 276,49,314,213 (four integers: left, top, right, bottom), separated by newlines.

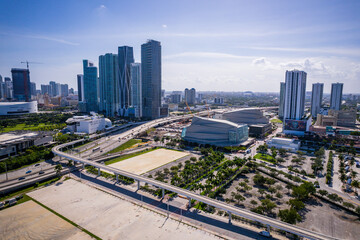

0,101,38,116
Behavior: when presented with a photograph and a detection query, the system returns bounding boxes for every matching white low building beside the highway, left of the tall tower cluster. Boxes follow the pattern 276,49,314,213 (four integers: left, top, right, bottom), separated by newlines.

66,112,112,134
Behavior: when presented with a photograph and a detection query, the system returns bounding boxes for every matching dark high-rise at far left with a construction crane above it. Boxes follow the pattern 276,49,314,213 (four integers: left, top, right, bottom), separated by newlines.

11,68,31,102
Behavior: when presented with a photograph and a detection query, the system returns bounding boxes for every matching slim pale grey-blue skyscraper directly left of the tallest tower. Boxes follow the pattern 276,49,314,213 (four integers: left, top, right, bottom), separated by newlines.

130,63,142,118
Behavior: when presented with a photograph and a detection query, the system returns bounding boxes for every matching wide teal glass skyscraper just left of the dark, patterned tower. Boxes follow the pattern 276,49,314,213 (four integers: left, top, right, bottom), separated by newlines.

99,53,120,117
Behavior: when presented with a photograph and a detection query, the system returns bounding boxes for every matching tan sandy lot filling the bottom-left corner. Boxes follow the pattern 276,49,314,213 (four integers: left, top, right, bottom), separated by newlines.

0,201,92,240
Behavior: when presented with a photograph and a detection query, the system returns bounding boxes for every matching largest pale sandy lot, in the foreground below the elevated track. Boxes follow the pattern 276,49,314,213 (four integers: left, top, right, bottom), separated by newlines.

29,180,218,240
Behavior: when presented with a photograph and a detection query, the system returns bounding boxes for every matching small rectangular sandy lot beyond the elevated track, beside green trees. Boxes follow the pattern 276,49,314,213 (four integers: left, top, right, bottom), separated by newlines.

109,149,188,174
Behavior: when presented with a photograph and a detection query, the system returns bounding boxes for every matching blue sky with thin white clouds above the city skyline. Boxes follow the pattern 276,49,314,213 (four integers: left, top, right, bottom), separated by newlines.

0,0,360,93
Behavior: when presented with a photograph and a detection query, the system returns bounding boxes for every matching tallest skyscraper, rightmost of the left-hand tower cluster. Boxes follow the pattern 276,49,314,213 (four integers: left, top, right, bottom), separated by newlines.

141,40,161,119
